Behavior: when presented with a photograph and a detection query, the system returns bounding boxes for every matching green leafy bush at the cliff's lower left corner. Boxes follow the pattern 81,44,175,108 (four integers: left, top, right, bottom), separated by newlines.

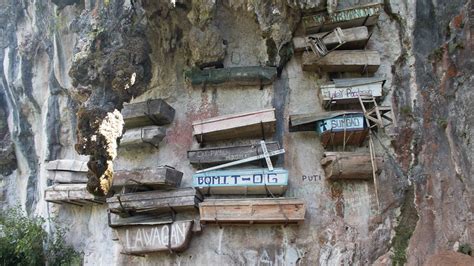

0,208,81,266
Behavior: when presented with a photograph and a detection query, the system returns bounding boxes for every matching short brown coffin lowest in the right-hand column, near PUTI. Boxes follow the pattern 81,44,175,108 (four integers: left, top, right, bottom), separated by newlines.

321,152,383,180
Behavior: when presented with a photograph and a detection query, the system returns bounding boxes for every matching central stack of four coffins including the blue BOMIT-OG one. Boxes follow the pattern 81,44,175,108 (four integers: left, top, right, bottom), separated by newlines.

188,108,305,224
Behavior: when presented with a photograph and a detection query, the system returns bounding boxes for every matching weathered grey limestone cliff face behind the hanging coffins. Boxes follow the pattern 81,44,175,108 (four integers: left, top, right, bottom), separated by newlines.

0,0,474,265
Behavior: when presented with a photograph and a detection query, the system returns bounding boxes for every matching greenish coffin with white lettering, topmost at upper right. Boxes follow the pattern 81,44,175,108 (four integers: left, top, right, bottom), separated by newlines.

302,3,383,33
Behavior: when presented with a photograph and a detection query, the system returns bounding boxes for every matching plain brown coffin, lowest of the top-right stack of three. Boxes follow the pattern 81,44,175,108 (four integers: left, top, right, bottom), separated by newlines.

302,50,380,73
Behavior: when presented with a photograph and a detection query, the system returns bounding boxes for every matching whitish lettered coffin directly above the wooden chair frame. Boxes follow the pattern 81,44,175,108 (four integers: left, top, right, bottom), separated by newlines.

320,78,385,106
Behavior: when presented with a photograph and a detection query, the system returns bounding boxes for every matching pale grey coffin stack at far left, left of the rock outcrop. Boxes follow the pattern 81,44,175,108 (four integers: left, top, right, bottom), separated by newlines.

44,159,105,206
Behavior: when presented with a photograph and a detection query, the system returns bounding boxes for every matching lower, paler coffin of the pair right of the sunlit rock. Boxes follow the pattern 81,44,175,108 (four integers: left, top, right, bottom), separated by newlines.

120,126,166,147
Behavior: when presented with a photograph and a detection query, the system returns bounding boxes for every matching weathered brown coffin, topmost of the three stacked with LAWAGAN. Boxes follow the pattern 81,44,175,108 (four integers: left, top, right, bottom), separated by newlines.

112,166,183,192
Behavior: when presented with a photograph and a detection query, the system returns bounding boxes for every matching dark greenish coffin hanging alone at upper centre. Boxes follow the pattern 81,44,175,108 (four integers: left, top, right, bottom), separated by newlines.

185,66,277,86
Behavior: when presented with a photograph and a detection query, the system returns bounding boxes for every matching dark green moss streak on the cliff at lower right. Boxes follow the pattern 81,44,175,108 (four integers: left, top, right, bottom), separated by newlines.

391,186,418,265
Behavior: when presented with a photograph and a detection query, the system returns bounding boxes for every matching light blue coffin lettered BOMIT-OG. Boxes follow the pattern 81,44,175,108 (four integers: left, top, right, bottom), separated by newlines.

193,168,288,195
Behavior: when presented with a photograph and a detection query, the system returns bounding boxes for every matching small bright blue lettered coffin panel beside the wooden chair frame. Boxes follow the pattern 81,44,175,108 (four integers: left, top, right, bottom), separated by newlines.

316,113,366,134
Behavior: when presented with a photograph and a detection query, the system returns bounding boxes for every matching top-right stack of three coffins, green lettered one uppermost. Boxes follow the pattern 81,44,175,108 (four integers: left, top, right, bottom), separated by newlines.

293,3,383,73
